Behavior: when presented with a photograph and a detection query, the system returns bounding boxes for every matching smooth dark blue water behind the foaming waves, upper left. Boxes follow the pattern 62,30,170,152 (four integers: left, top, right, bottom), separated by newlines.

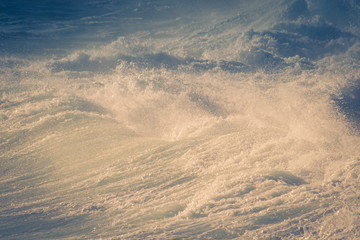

0,0,242,55
